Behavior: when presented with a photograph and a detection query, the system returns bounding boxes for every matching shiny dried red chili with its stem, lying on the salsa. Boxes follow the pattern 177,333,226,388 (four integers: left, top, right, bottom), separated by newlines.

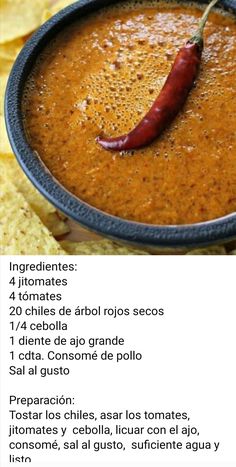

97,0,218,151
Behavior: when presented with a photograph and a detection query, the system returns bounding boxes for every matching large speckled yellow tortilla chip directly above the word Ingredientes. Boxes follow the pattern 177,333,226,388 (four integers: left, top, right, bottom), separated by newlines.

0,175,66,255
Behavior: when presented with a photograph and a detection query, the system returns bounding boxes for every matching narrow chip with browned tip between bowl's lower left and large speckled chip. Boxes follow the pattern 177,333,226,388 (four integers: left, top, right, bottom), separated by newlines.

0,155,70,237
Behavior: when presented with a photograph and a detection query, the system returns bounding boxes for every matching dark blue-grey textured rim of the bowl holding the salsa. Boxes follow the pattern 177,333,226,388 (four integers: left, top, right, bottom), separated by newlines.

5,0,236,252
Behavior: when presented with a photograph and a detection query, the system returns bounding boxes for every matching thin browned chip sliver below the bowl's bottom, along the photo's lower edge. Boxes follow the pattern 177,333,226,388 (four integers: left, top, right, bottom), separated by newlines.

60,240,148,255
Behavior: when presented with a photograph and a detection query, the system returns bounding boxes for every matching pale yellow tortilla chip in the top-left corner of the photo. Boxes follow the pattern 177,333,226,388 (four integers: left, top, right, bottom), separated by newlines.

0,0,48,44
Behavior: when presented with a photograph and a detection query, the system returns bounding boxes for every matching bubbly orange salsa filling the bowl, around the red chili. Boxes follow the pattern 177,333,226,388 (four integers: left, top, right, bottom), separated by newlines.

23,1,236,225
